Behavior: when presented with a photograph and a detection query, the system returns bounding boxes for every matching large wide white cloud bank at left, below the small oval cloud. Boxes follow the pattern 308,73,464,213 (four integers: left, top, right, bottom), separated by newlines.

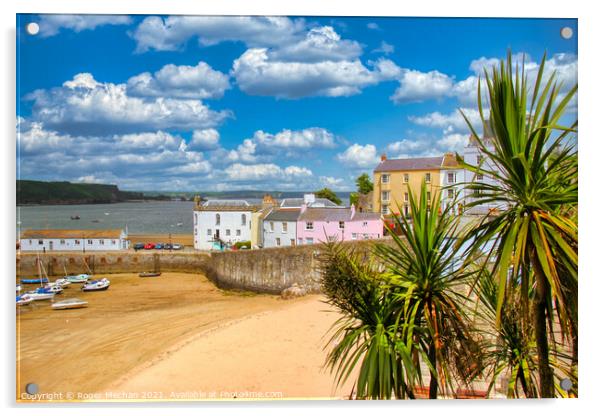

27,73,230,135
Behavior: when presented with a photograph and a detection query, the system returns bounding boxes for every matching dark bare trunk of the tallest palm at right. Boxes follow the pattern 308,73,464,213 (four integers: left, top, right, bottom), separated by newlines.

531,249,554,398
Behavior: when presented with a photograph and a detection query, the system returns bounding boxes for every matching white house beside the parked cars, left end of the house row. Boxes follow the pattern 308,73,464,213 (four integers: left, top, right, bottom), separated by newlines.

193,199,261,250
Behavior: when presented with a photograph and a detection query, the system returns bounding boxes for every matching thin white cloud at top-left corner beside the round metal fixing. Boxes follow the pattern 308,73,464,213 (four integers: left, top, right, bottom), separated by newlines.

37,14,132,38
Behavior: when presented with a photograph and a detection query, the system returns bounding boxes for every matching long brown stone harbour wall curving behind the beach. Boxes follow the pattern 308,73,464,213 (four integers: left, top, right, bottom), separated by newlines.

17,239,391,293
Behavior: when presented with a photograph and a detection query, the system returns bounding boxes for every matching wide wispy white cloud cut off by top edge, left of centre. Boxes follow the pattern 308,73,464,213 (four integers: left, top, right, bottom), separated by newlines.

132,16,305,52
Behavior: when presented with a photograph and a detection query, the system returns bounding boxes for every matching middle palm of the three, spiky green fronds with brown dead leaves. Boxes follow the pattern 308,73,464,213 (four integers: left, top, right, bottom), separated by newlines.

375,182,478,399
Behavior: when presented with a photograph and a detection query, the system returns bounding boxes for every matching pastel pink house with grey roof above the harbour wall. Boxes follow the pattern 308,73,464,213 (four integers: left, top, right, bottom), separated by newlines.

297,205,383,245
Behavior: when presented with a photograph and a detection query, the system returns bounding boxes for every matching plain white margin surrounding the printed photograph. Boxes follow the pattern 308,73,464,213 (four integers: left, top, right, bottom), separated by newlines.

0,0,602,415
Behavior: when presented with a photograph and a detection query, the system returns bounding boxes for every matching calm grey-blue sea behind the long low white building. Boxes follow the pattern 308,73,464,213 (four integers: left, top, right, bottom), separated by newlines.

17,201,194,234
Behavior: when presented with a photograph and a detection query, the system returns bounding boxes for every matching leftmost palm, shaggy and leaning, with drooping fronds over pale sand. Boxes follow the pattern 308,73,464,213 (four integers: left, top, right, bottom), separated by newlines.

319,242,415,399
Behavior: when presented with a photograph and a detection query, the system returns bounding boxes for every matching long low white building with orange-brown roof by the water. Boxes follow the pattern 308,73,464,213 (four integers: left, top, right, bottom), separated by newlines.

19,230,129,252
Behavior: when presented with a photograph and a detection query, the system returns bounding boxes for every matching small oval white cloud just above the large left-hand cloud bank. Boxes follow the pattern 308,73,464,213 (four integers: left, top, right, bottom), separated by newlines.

127,61,230,100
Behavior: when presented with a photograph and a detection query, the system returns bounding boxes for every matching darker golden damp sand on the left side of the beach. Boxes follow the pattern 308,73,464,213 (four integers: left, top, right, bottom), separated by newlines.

17,273,297,399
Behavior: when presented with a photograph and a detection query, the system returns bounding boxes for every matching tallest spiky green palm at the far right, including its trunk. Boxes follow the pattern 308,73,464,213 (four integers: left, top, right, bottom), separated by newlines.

457,52,578,397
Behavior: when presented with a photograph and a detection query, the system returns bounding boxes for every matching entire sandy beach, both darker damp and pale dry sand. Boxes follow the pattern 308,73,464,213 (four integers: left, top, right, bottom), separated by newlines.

17,273,351,401
